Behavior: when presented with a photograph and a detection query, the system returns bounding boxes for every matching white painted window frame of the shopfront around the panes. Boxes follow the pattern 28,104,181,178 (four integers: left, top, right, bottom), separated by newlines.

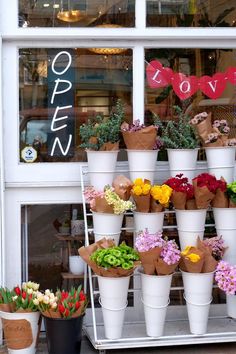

0,0,236,286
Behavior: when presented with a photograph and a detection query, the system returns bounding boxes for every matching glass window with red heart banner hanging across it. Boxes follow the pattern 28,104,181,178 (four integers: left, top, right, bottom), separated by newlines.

145,48,236,159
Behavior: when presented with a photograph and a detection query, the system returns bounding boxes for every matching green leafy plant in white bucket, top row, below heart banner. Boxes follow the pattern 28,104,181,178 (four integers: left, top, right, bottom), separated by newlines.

155,106,199,181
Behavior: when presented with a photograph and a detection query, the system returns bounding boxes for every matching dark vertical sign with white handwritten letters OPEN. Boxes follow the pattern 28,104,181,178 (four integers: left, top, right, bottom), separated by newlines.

47,49,75,157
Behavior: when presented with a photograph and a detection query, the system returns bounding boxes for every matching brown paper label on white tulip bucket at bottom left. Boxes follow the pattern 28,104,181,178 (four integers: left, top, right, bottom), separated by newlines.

2,318,33,350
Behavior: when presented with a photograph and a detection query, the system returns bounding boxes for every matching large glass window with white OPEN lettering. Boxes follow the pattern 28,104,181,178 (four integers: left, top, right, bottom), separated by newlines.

19,48,133,163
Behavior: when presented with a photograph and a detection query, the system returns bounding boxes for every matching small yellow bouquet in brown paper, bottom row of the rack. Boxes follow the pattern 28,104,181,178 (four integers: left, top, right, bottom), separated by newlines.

179,246,205,273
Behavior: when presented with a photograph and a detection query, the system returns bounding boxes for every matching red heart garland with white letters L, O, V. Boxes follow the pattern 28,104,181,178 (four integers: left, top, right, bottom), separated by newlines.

146,60,236,100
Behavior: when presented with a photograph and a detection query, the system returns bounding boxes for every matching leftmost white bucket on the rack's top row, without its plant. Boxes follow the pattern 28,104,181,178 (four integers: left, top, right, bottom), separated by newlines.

86,150,119,190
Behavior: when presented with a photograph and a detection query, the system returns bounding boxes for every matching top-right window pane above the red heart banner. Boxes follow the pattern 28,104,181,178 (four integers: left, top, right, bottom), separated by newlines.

147,0,236,27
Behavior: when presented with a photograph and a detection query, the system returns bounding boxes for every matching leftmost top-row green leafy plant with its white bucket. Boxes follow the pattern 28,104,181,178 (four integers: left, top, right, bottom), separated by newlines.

80,100,124,190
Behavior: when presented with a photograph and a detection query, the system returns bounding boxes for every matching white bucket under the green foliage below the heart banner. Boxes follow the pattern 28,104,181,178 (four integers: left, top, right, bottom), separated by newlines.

167,149,199,183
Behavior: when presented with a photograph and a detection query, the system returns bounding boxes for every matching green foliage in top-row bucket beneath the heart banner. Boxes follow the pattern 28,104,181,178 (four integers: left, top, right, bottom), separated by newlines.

155,106,198,149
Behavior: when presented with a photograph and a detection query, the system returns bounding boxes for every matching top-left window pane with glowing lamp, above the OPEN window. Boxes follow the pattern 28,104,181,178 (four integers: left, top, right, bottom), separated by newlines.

18,0,135,27
